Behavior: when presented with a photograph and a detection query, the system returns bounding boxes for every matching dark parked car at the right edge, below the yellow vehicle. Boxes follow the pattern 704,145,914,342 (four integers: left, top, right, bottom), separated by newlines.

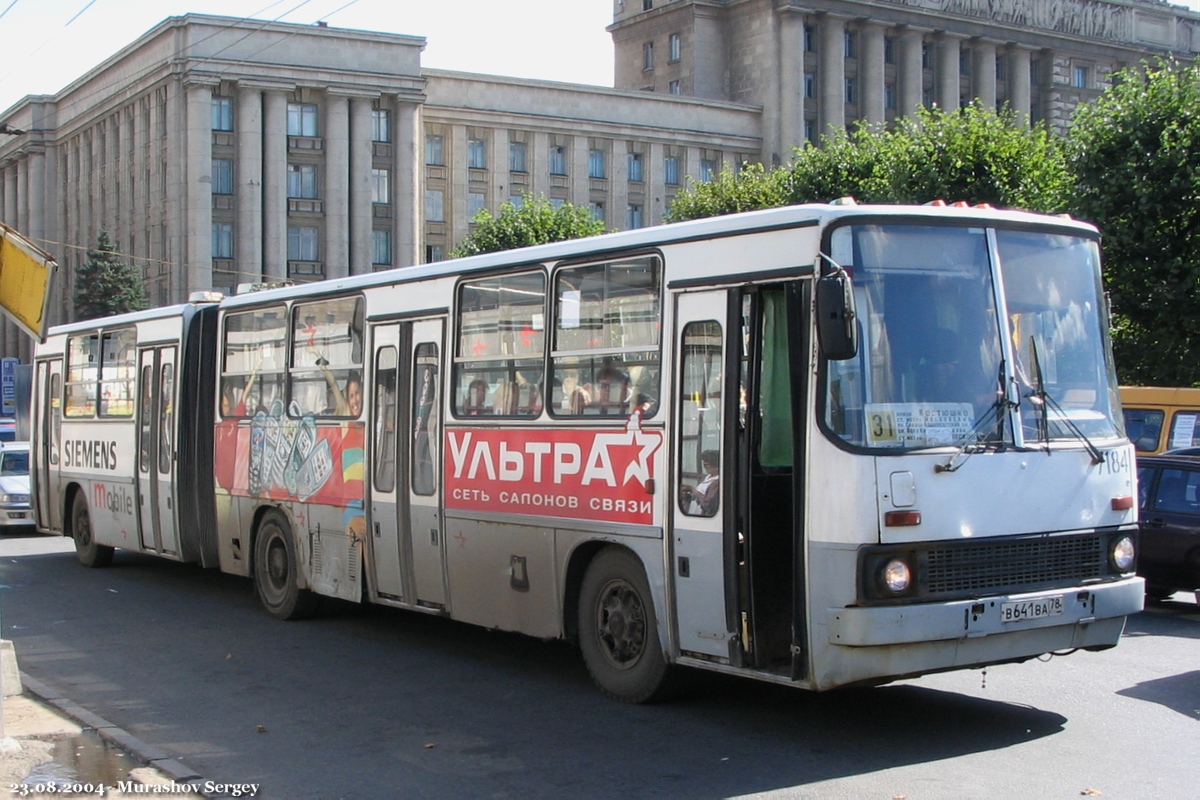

1138,455,1200,599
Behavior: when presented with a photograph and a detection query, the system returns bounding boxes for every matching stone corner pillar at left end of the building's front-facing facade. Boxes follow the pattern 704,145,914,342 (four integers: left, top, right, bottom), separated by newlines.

184,84,212,300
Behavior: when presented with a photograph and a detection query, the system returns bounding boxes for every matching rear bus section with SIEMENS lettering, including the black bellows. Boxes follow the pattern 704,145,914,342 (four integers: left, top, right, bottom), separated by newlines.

31,303,216,566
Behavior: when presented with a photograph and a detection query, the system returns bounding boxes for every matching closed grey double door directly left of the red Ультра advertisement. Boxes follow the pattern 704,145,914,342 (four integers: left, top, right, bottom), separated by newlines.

371,319,446,607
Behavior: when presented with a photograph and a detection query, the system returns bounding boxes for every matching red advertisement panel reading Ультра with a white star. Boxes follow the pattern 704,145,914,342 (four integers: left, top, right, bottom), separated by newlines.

445,415,662,524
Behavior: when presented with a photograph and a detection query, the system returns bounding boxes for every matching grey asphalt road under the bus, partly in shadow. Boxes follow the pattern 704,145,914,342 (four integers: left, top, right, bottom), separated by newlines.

0,535,1200,800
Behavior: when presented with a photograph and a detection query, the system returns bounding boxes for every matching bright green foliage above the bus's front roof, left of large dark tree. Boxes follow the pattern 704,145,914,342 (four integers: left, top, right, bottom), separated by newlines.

668,104,1070,222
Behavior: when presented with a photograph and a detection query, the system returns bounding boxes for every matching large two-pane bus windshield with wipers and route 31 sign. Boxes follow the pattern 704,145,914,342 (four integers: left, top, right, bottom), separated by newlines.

824,223,1121,450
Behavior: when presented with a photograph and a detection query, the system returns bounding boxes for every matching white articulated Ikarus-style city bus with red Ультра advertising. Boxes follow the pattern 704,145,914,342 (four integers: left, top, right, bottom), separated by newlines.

34,204,1144,702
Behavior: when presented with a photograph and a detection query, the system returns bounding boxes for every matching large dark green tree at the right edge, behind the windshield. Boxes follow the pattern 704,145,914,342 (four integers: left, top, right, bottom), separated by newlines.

1069,62,1200,386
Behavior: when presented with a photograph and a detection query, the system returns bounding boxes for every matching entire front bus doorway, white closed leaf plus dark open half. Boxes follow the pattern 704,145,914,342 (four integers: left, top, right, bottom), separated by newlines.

671,284,806,678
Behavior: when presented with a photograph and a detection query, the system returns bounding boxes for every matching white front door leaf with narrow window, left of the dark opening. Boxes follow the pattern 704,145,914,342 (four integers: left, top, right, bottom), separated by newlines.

671,291,742,663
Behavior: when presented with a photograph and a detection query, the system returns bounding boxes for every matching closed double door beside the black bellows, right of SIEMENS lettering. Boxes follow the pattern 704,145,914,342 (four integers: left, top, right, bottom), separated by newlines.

138,347,179,554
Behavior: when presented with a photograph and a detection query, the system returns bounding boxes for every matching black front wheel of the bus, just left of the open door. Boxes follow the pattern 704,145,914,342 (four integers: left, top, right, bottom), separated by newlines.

578,547,668,703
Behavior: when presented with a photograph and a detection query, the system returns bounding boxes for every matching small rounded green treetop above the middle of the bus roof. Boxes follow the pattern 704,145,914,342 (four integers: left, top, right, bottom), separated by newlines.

450,196,605,258
